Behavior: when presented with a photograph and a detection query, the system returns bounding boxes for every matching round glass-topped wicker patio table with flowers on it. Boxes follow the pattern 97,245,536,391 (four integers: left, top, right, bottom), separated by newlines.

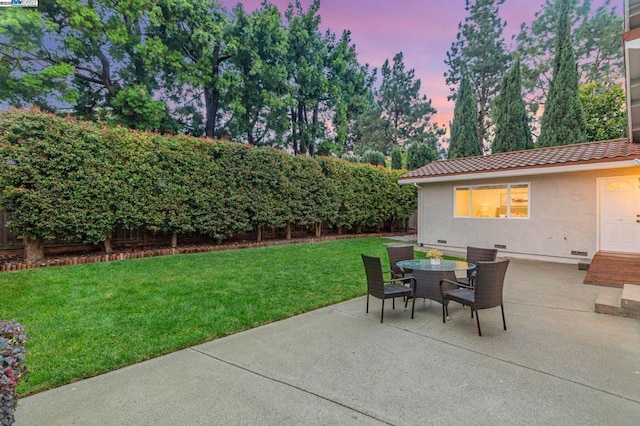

396,259,476,303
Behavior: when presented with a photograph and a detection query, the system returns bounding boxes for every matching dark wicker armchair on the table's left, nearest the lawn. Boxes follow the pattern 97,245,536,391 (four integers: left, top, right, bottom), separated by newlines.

362,254,416,323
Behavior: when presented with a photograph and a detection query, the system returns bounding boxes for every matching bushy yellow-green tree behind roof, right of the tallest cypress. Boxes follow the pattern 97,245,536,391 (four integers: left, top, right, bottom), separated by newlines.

579,83,627,141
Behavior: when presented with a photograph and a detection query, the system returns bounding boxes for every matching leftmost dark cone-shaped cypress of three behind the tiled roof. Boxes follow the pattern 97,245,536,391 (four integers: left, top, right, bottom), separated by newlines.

448,74,482,160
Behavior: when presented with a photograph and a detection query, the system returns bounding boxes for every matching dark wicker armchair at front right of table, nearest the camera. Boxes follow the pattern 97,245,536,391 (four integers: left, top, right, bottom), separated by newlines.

440,259,509,336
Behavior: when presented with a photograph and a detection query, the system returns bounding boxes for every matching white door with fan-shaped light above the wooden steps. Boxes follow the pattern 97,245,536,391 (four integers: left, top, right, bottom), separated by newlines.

598,177,640,253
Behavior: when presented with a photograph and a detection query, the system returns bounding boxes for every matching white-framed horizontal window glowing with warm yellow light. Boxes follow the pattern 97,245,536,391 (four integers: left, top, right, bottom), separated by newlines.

454,183,529,219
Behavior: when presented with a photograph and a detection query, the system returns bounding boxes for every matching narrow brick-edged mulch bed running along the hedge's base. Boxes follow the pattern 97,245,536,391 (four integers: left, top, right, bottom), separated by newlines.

0,232,416,272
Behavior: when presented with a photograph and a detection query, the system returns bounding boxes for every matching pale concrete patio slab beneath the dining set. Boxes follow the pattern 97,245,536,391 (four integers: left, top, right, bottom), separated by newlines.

16,260,640,426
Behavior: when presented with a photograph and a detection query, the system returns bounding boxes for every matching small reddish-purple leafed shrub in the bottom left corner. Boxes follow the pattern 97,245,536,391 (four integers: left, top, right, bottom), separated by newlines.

0,320,27,426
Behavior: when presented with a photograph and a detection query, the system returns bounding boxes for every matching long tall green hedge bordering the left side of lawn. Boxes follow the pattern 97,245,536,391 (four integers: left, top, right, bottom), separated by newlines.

0,110,417,260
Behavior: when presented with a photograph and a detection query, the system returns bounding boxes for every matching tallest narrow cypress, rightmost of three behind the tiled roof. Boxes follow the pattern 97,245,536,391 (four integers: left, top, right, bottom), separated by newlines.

538,0,586,146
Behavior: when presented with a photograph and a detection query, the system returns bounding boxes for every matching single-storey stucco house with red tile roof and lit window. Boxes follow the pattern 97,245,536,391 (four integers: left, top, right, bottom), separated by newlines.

399,139,640,263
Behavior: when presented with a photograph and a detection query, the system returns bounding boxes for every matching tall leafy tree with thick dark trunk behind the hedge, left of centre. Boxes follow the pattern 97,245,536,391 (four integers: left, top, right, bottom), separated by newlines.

146,0,231,137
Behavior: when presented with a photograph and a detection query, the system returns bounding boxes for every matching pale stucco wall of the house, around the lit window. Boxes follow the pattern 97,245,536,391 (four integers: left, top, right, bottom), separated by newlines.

418,167,640,263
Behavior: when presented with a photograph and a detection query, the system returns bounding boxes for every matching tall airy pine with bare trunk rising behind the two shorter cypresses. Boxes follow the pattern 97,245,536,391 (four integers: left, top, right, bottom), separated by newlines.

445,0,509,152
